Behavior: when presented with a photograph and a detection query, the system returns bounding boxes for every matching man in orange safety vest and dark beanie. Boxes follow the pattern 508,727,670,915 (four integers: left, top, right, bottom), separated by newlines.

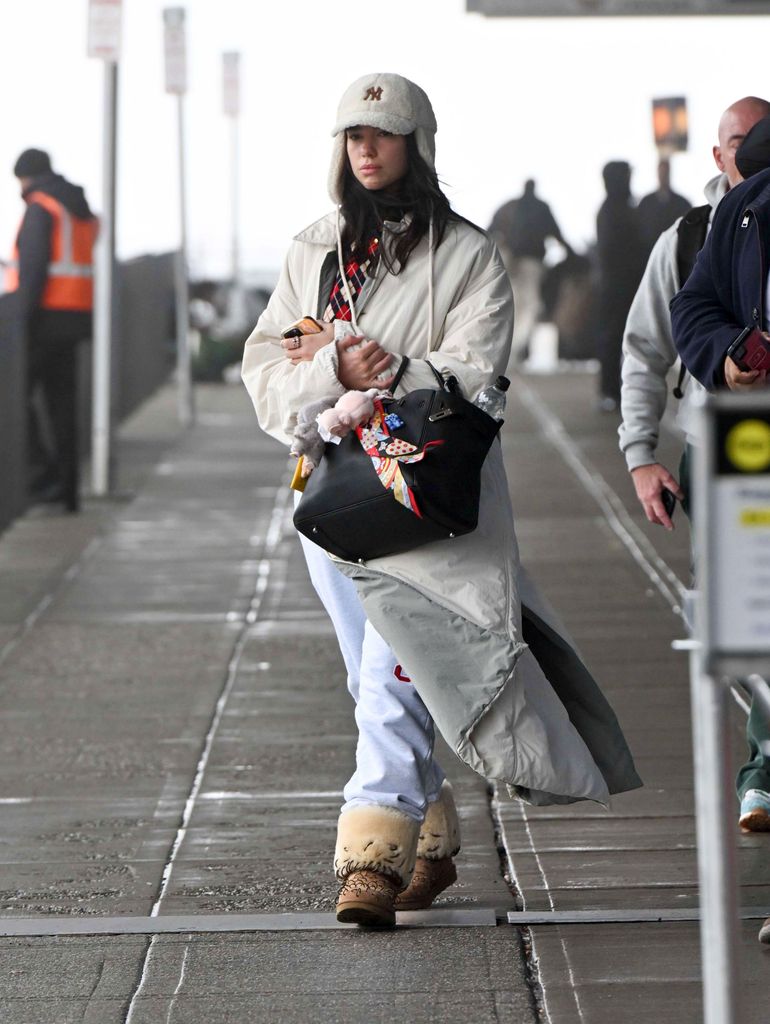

5,150,97,512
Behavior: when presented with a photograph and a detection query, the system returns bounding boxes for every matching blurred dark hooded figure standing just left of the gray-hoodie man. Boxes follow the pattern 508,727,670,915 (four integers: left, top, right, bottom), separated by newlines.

596,160,645,413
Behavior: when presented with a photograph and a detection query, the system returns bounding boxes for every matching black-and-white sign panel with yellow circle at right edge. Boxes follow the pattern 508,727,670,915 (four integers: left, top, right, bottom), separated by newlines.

694,395,770,671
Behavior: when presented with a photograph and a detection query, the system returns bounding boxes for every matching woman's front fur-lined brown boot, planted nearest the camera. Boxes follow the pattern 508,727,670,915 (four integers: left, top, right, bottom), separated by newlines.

334,804,420,928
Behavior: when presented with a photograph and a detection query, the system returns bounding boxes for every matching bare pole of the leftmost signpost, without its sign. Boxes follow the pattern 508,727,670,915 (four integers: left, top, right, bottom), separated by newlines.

91,60,118,498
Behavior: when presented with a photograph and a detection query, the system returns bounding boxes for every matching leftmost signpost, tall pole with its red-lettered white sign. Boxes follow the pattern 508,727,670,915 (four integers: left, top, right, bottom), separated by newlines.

88,0,122,498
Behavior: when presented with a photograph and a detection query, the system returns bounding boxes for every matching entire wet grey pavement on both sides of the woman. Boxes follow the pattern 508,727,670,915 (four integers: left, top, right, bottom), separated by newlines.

0,375,770,1024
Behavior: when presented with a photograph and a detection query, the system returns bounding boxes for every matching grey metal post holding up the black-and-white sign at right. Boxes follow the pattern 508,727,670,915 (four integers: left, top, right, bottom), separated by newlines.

690,649,742,1024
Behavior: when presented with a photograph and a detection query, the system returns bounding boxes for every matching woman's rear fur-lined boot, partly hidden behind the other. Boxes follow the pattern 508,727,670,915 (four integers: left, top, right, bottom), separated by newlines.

395,780,460,910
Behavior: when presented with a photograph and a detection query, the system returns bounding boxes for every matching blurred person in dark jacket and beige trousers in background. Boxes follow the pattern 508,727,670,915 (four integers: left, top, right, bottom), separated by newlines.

489,178,572,365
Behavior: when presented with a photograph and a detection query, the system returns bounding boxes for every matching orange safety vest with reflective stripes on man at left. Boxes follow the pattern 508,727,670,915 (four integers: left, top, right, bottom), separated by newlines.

5,191,98,311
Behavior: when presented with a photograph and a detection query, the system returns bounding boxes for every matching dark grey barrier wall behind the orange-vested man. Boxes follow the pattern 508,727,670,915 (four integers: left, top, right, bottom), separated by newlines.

0,253,175,530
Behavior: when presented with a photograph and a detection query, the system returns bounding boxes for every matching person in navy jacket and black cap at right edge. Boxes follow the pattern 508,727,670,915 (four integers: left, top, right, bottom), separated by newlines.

671,116,770,942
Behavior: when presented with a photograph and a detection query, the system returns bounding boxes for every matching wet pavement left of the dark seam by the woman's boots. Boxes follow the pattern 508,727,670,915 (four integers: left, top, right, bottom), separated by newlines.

0,387,536,1024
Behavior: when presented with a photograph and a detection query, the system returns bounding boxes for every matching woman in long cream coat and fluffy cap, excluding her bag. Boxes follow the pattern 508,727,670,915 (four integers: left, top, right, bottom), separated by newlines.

243,74,640,926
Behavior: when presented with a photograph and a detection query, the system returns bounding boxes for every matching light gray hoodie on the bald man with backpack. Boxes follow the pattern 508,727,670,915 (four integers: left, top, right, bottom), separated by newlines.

617,174,728,471
